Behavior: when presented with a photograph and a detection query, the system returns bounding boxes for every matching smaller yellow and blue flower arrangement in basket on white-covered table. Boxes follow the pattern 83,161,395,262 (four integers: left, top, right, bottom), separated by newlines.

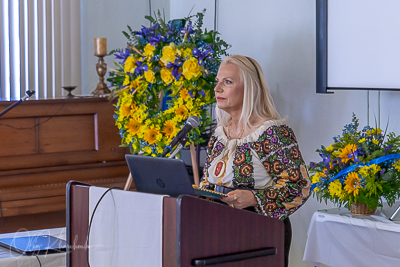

309,114,400,210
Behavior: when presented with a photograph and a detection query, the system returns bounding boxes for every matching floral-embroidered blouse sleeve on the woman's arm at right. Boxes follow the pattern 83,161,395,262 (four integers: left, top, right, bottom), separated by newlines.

251,125,310,220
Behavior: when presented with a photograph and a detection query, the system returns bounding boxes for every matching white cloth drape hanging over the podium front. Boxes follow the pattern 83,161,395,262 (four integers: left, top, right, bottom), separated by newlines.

89,186,164,267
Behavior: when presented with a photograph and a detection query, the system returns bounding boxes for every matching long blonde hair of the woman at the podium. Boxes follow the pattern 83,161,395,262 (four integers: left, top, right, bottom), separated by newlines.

215,55,281,128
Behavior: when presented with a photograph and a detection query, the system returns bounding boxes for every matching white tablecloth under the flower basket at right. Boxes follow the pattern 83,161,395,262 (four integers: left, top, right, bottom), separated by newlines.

303,208,400,267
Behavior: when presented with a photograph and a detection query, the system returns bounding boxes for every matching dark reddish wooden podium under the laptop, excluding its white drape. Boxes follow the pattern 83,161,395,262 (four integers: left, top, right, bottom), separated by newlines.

67,181,284,267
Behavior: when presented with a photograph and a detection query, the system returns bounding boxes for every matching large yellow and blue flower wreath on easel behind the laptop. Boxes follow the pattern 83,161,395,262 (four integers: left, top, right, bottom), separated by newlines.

107,10,229,156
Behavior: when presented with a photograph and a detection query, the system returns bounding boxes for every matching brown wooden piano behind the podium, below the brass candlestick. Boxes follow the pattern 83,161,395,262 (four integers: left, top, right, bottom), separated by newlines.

0,97,129,231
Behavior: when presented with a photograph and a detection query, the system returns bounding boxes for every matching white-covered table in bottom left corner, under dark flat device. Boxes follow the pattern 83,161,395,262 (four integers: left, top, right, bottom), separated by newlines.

0,227,66,267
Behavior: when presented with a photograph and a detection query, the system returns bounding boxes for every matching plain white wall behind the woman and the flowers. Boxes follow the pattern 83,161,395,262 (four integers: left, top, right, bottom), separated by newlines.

82,0,400,267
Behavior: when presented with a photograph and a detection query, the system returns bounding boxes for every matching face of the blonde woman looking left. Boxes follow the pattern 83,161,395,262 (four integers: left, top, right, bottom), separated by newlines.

214,64,244,116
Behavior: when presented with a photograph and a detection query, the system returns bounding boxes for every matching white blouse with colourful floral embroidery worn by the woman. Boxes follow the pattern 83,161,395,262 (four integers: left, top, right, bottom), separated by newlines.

200,120,310,219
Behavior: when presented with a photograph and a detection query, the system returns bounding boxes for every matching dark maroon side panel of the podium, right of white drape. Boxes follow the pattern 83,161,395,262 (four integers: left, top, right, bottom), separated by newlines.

177,196,284,267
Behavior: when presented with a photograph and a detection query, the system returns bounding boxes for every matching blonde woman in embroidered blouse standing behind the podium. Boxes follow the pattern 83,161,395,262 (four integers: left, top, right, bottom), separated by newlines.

200,55,310,266
